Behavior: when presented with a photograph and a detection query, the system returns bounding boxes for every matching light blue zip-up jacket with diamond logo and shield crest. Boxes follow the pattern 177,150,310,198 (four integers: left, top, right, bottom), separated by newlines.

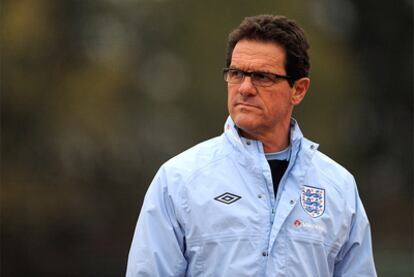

126,117,376,277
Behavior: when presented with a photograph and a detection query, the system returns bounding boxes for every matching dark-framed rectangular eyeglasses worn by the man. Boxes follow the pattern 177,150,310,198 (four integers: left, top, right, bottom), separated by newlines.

223,68,292,87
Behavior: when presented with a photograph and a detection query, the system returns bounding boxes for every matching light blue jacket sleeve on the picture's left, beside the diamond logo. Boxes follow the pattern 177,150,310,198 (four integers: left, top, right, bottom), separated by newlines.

126,168,187,277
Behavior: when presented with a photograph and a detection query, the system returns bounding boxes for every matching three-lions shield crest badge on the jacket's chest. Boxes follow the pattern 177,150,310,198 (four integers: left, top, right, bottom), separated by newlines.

300,186,325,217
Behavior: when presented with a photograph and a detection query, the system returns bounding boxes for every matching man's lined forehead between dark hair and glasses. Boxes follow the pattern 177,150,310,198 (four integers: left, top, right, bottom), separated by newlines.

230,40,285,73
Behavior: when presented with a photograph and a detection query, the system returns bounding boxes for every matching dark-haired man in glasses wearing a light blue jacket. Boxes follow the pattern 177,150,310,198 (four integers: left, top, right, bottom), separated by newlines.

127,15,376,277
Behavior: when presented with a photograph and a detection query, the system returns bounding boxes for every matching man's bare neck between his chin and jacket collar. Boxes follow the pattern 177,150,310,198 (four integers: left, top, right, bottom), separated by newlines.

241,122,290,153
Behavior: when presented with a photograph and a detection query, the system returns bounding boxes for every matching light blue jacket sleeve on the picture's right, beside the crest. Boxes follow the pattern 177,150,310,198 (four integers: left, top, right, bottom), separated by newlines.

333,182,377,277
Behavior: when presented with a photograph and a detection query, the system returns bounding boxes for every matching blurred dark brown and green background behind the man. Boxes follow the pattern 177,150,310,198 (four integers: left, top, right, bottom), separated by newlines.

0,0,414,276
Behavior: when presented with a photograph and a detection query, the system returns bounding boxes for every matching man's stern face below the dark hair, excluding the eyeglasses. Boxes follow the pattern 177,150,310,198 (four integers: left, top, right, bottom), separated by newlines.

228,40,296,138
